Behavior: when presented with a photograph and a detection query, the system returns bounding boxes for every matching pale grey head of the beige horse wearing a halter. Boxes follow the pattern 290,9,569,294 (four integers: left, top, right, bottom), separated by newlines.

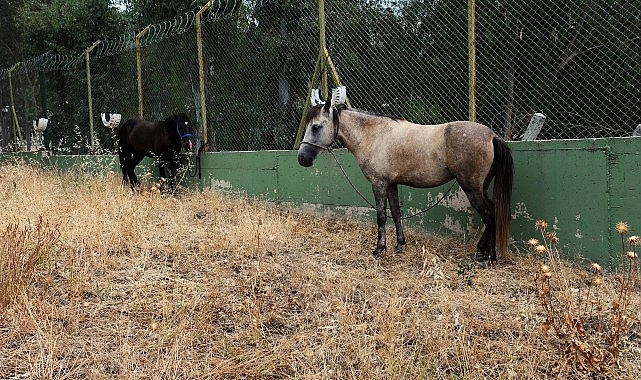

298,87,345,167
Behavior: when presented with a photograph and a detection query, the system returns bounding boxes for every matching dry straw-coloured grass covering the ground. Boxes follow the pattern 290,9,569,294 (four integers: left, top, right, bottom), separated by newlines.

0,166,641,379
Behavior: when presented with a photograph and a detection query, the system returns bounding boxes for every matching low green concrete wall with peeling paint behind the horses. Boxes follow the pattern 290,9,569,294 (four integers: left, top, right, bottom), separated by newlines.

0,138,641,266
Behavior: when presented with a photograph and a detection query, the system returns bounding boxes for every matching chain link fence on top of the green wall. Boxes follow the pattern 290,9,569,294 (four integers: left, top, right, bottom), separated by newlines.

0,0,641,154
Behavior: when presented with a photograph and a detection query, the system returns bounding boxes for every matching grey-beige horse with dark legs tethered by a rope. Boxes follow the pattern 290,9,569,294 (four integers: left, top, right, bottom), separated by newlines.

298,87,513,264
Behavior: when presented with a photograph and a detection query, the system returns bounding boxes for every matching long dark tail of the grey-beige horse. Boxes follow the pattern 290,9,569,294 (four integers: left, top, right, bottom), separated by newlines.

492,137,514,257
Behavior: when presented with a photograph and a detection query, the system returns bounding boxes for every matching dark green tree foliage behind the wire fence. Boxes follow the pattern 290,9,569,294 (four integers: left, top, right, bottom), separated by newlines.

0,0,641,150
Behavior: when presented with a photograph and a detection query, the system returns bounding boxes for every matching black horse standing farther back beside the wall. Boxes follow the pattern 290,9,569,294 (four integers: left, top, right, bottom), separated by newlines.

116,113,193,192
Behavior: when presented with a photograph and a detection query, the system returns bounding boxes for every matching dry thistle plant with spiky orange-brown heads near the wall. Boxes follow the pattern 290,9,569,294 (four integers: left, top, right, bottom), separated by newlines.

528,220,641,377
